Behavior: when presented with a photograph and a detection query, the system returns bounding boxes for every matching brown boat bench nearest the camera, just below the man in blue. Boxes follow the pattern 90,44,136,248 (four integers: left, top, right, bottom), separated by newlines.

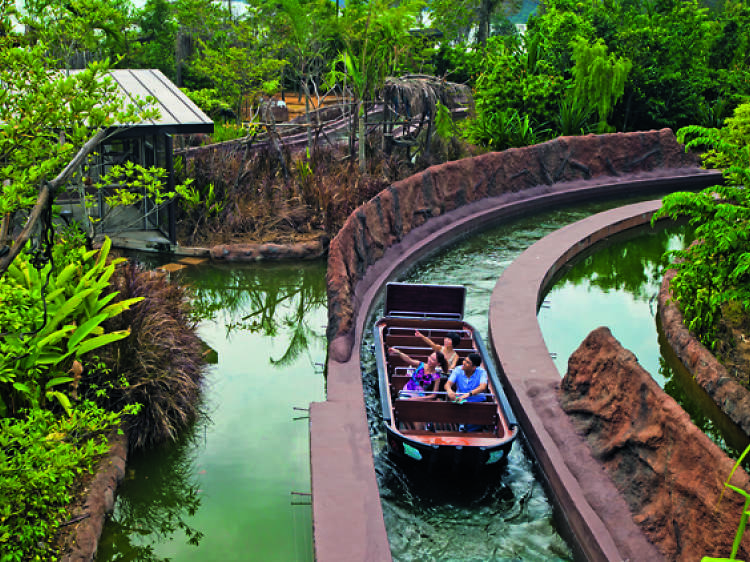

393,400,499,428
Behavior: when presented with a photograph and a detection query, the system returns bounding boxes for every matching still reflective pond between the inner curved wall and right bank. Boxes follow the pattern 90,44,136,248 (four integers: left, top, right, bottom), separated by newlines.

537,221,748,458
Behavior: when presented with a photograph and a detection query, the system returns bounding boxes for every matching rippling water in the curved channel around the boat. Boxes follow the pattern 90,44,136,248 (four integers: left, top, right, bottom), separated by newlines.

362,197,672,561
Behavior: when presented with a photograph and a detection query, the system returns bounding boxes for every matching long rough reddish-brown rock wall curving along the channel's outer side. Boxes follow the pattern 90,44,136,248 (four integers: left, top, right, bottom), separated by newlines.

327,129,697,361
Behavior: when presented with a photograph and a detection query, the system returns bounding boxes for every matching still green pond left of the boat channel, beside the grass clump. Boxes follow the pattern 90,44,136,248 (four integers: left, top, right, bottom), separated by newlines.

97,261,327,561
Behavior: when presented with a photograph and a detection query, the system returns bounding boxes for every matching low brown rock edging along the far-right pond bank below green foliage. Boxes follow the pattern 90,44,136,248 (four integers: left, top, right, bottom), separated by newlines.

659,270,750,435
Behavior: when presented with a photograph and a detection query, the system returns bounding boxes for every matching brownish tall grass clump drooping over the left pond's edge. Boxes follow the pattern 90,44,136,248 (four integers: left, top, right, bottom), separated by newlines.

87,263,203,449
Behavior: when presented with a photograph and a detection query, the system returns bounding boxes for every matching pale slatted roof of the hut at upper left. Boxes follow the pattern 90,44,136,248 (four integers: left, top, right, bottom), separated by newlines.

109,69,214,134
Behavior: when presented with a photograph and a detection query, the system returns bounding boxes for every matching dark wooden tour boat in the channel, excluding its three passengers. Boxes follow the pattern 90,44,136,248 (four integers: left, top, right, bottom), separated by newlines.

374,283,518,476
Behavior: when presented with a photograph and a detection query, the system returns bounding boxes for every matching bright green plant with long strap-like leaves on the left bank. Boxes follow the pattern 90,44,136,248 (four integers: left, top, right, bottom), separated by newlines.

0,235,142,417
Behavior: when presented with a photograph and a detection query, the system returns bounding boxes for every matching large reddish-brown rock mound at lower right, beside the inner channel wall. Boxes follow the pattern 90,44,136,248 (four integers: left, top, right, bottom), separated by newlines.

560,328,750,561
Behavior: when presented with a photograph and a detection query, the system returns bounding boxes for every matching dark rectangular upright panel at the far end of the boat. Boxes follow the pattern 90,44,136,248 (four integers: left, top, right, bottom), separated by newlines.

385,283,466,320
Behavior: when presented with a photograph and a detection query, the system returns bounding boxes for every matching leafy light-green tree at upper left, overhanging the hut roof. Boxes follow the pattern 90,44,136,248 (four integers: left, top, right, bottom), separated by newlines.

0,0,181,277
